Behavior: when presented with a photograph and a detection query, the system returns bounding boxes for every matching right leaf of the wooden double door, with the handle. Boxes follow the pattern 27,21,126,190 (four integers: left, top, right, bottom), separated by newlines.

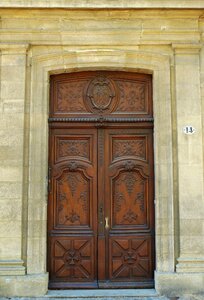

105,128,154,287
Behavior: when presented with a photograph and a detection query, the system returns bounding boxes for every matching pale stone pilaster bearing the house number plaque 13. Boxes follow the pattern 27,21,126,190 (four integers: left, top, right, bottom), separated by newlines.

173,44,204,273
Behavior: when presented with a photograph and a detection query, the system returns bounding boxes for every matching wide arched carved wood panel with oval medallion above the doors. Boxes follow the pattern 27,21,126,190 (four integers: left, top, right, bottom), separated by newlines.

50,71,152,117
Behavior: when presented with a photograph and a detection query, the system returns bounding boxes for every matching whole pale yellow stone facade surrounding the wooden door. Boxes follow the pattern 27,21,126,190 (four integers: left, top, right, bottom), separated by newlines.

0,0,204,297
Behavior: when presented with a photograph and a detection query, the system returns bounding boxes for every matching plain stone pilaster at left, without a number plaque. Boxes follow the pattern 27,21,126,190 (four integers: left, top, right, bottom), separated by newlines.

0,44,27,275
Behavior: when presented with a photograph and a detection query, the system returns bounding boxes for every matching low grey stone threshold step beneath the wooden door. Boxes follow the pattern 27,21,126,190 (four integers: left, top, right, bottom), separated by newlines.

44,289,159,299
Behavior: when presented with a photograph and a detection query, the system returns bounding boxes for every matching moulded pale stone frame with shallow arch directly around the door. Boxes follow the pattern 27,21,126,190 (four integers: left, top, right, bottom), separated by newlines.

24,47,176,288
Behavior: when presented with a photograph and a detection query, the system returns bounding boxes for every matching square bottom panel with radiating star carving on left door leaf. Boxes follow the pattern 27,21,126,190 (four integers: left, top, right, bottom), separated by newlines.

51,237,95,282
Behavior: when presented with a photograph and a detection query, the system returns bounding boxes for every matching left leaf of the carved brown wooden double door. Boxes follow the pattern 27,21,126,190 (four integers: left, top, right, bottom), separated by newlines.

48,128,97,288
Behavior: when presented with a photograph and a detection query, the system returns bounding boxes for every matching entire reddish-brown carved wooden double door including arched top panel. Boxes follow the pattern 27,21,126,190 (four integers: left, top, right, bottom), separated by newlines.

48,72,154,288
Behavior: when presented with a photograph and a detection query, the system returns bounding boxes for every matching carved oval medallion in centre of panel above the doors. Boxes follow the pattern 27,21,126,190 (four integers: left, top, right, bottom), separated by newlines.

85,76,117,113
